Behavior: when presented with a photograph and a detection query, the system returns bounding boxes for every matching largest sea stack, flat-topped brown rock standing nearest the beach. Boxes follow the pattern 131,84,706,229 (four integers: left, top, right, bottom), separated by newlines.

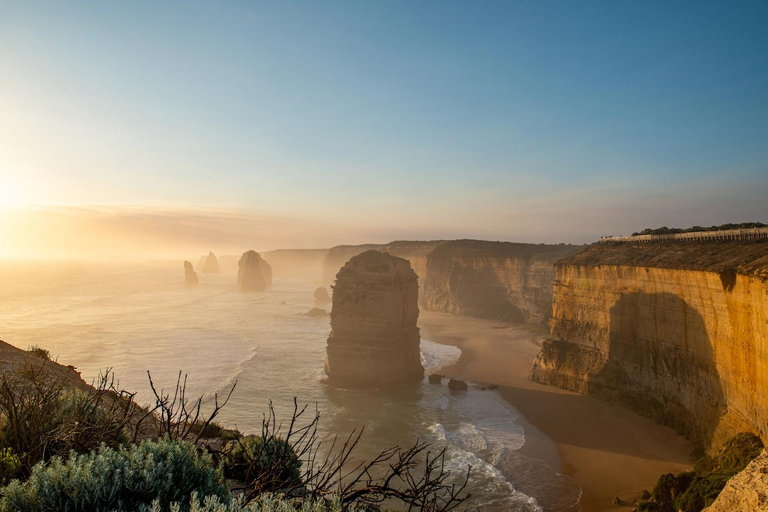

325,250,424,388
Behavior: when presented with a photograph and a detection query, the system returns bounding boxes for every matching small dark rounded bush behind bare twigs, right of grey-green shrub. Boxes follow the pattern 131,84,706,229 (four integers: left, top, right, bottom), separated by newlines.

224,435,301,492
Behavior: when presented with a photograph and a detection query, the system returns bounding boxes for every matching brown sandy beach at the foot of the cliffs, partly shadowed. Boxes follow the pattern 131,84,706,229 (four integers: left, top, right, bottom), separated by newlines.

419,312,692,512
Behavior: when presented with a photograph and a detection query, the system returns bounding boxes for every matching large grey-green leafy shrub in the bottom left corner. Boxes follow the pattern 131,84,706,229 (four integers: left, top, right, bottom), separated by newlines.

0,439,227,512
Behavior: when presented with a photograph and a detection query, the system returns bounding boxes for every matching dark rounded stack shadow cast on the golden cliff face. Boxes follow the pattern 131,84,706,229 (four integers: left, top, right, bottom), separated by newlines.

600,292,727,448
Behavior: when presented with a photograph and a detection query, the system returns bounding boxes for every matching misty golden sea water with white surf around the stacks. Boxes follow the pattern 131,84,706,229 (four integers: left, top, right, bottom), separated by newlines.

0,261,580,512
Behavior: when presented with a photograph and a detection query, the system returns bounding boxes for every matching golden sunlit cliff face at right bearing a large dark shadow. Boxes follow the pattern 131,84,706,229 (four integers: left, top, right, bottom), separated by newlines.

531,241,768,450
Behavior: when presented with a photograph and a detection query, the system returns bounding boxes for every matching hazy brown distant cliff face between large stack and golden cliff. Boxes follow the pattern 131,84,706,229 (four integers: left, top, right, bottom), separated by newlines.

421,240,583,323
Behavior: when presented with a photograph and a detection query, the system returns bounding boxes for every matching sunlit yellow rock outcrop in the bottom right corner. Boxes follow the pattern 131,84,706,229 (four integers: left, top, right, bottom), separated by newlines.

704,450,768,512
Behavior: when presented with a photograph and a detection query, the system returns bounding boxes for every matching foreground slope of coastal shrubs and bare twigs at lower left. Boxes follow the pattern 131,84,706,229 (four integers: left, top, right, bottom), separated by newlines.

0,349,469,512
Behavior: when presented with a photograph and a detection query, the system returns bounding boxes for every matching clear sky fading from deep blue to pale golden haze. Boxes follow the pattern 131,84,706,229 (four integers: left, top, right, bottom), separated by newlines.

0,0,768,256
